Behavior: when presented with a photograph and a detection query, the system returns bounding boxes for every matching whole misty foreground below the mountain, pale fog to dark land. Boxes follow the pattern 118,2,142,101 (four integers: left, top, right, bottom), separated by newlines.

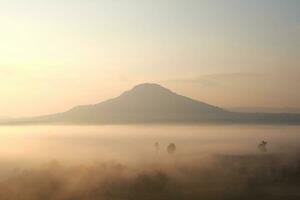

0,126,300,200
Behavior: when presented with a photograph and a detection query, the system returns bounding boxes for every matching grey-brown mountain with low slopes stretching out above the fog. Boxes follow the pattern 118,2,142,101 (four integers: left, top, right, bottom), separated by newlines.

2,83,300,124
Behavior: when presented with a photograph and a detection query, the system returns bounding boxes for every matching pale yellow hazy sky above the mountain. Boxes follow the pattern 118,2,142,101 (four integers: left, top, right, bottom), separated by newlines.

0,0,300,116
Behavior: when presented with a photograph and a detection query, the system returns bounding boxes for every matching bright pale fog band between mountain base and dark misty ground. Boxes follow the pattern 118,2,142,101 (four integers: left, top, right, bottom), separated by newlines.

0,125,300,164
